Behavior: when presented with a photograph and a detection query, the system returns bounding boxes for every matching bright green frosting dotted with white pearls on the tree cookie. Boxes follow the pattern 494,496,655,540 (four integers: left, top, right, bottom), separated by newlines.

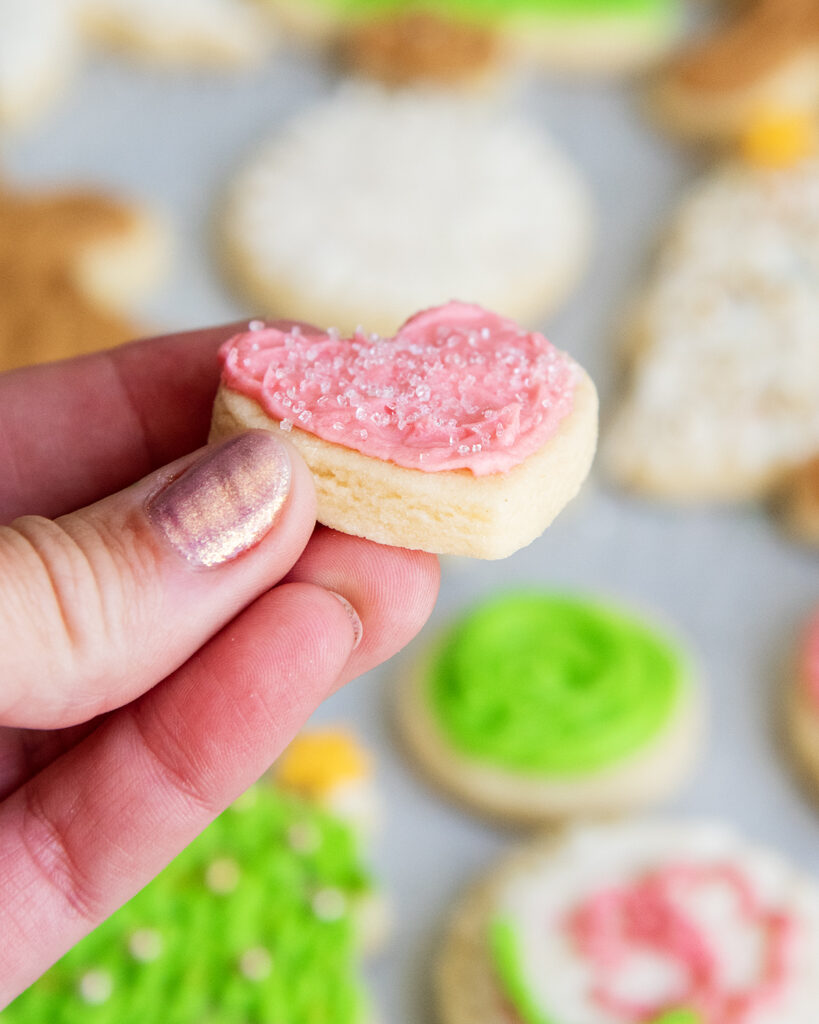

0,783,369,1024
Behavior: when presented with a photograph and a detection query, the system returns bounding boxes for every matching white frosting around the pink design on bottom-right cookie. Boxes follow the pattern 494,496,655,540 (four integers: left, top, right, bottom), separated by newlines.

494,822,819,1024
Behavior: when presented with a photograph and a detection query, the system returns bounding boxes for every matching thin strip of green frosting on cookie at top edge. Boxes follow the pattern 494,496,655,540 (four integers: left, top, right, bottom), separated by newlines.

311,0,679,22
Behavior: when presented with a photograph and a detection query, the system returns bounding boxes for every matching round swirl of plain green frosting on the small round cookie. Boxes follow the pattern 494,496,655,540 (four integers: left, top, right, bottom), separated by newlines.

426,593,688,776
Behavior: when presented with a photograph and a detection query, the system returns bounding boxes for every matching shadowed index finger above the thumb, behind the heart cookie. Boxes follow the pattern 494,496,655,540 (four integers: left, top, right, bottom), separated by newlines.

0,322,241,522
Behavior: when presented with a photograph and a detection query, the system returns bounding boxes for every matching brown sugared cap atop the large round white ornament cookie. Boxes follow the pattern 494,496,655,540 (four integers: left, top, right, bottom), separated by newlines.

338,10,502,86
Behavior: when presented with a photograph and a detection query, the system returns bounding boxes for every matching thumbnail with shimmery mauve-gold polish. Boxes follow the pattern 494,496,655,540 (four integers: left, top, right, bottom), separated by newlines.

146,430,291,566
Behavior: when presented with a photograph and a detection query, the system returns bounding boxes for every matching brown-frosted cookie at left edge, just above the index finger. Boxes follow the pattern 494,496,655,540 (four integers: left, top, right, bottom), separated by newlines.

0,184,165,370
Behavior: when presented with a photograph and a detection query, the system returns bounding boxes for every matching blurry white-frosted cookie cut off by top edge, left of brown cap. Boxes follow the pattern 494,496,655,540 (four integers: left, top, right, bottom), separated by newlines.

77,0,272,67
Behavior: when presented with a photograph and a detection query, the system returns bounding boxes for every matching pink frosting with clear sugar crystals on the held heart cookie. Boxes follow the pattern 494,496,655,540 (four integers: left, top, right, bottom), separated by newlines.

220,302,577,476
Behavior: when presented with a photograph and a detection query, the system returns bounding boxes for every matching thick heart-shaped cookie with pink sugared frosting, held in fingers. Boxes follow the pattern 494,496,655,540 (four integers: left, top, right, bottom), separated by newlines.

207,302,597,558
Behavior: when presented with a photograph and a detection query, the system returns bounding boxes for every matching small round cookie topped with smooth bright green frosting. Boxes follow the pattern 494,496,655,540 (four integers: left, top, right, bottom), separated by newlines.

395,591,702,824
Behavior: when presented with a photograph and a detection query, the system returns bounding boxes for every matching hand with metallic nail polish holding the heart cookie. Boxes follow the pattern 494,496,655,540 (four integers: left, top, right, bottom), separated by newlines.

0,328,438,1008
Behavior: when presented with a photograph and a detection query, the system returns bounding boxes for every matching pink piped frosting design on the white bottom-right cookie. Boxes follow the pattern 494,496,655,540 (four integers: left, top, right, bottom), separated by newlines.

569,864,794,1024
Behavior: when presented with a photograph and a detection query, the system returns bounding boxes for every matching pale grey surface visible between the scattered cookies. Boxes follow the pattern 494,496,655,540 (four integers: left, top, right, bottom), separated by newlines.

2,36,819,1024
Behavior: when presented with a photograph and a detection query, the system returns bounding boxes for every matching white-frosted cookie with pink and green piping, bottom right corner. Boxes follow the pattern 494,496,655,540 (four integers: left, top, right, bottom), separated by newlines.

437,820,819,1024
